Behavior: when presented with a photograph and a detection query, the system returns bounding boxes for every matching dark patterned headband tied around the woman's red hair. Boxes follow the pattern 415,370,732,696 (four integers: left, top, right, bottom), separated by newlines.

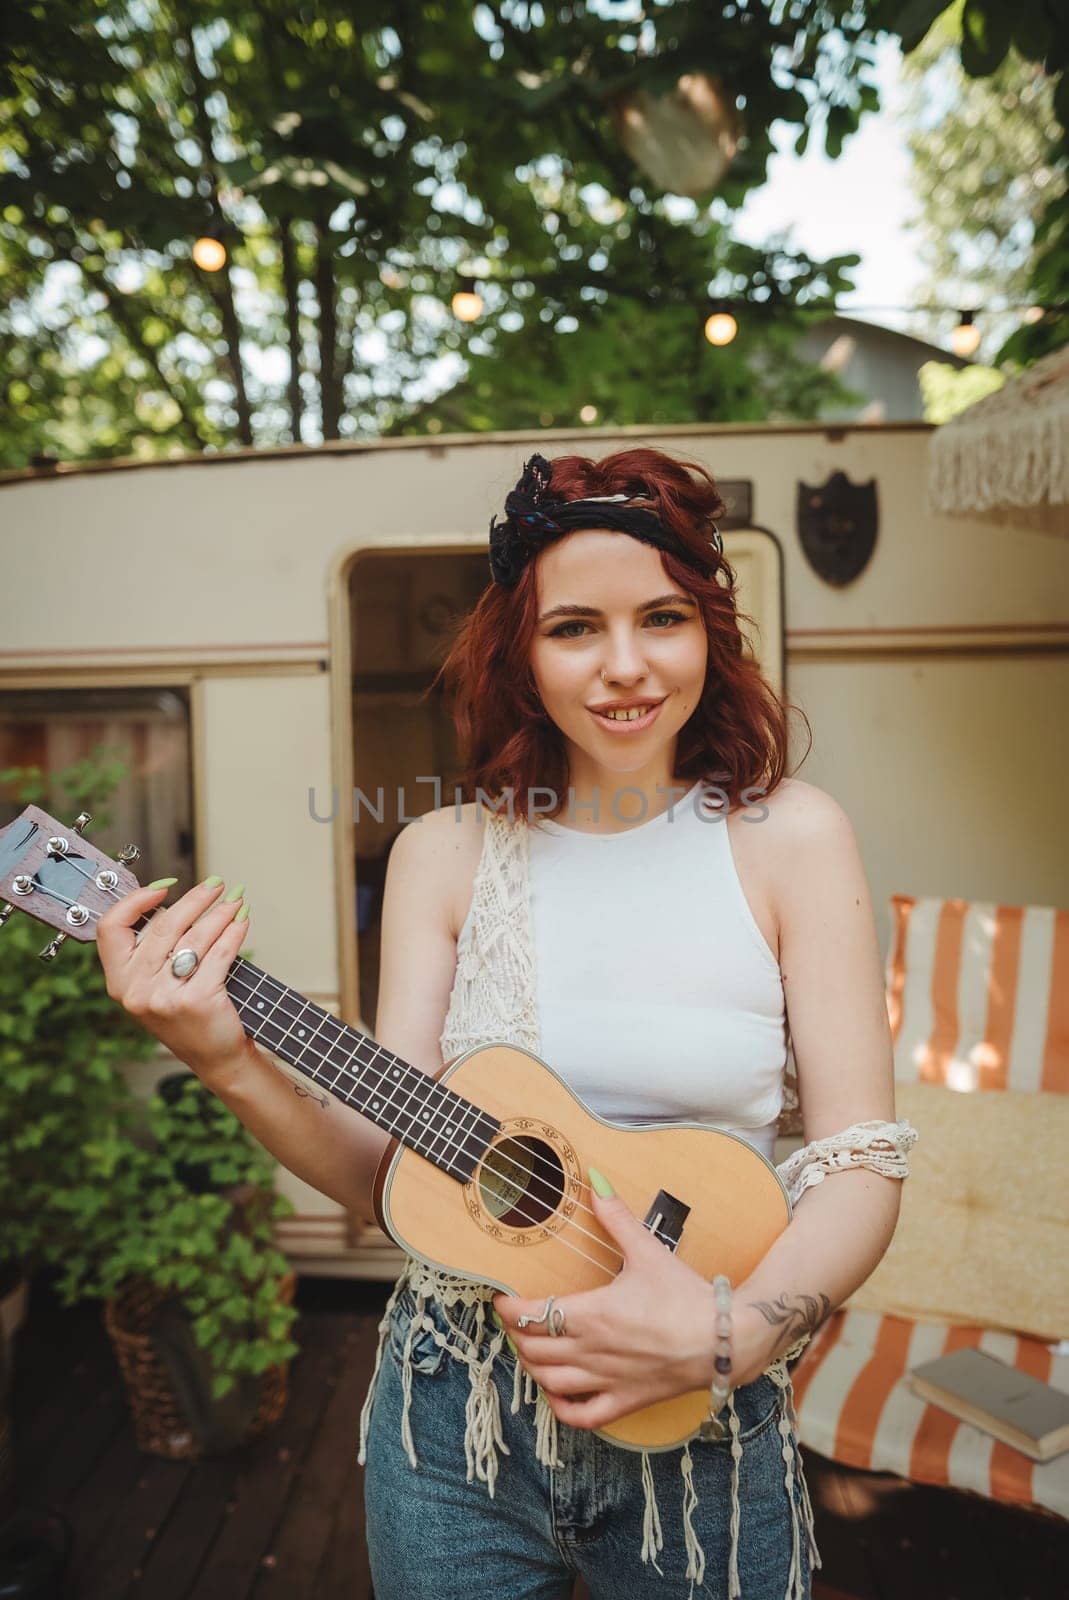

490,456,723,589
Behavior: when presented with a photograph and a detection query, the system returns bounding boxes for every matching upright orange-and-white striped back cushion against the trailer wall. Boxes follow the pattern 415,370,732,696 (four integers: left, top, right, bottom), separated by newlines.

887,894,1069,1094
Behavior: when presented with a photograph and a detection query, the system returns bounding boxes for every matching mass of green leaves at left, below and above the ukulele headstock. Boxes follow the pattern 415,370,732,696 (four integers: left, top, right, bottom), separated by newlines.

0,762,294,1408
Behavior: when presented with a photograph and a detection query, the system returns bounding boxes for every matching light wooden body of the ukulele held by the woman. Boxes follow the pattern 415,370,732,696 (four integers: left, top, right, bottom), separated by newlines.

374,1045,791,1450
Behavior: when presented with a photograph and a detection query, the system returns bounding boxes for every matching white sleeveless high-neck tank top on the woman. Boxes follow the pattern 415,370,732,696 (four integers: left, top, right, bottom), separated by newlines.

458,781,787,1160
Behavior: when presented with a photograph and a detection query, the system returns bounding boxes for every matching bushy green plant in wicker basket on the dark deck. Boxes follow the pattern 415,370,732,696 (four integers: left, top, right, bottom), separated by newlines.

56,1072,296,1456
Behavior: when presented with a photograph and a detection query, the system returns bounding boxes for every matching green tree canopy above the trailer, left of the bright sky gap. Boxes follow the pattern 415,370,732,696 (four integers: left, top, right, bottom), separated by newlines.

0,0,902,466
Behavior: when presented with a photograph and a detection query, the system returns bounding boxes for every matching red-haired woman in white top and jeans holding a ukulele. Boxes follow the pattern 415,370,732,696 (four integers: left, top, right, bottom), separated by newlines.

98,450,915,1600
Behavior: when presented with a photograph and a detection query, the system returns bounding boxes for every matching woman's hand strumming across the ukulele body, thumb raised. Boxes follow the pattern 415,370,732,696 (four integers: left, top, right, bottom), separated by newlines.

493,1187,768,1429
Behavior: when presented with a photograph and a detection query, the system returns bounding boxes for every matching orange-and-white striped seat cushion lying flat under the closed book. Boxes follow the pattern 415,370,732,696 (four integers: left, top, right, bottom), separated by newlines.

792,1307,1069,1517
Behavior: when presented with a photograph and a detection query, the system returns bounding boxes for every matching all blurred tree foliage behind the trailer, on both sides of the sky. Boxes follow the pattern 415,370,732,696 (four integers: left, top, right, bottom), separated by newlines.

0,0,1069,467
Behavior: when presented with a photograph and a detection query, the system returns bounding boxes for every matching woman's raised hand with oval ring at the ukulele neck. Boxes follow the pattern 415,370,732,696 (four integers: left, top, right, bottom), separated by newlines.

96,880,254,1085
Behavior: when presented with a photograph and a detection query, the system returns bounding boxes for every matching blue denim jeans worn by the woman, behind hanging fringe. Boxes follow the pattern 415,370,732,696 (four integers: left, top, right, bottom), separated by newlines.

365,1288,811,1600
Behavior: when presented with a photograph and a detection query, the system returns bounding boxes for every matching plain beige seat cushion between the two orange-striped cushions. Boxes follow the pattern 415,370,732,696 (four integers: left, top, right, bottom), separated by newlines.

844,1083,1069,1339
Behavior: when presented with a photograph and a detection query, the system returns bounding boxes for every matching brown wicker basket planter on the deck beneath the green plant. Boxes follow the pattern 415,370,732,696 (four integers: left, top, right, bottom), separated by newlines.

104,1272,298,1461
